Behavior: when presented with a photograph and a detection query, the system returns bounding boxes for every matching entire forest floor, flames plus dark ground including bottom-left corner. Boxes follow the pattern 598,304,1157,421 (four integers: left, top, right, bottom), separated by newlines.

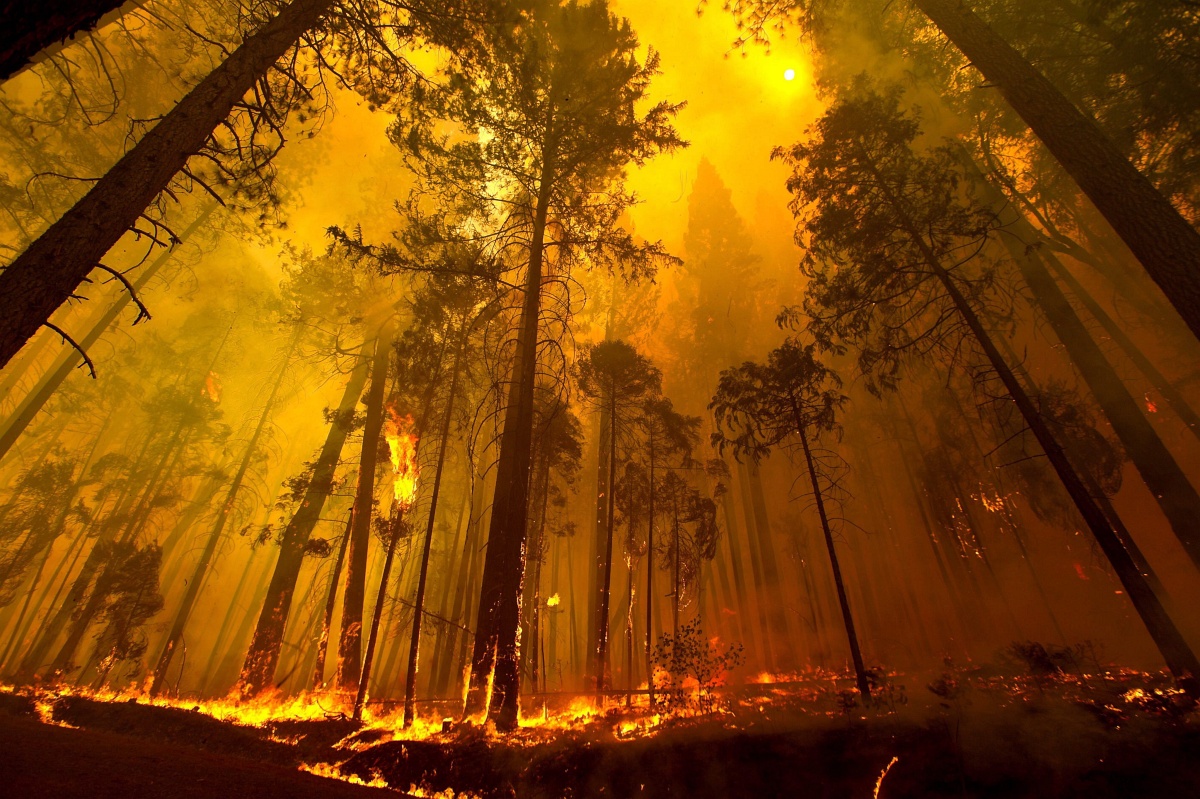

0,673,1200,799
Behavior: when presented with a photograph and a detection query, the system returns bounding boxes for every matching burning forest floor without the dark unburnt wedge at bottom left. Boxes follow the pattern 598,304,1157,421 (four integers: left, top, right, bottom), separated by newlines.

0,669,1200,799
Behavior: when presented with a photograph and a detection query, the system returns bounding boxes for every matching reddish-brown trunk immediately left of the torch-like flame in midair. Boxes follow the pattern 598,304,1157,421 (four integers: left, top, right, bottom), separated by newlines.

337,320,391,692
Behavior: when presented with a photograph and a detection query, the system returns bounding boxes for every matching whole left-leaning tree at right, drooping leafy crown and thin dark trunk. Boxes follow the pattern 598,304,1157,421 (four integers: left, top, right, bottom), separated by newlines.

776,79,1200,690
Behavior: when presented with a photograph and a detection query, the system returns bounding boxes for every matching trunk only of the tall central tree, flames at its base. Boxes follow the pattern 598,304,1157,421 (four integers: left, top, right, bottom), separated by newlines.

466,138,554,729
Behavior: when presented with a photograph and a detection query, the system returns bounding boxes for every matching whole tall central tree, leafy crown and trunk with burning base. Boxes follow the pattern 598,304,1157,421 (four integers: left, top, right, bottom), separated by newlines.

394,0,682,728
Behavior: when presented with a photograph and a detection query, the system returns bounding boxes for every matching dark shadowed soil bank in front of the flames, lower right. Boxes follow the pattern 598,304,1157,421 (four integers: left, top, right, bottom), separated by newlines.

342,707,1200,799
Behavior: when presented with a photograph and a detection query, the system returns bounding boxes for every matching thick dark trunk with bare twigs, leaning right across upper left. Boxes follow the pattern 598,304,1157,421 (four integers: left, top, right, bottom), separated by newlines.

0,0,334,366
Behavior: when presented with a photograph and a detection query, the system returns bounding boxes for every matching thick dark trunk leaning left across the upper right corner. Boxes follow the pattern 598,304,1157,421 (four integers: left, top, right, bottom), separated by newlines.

911,0,1200,336
